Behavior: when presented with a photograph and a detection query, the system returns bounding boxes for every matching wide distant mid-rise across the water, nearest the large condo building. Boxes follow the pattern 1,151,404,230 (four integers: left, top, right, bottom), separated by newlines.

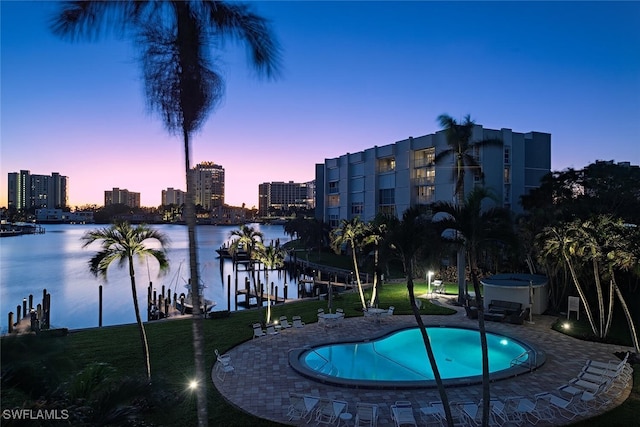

258,181,315,216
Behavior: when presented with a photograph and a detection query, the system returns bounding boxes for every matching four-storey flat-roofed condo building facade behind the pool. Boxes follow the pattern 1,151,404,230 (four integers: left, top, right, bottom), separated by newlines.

316,124,551,227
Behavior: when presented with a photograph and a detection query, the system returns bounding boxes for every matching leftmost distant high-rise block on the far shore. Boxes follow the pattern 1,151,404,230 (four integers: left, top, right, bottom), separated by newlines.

7,170,68,209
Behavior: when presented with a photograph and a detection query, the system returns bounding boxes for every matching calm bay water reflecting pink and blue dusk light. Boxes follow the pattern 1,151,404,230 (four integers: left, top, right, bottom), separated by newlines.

0,224,296,333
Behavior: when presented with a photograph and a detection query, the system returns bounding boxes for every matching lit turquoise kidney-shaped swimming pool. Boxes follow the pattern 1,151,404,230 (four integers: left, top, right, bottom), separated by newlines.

289,326,544,388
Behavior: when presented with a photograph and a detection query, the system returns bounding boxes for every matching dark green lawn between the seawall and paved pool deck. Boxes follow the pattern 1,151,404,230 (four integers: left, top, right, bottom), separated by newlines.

2,282,640,426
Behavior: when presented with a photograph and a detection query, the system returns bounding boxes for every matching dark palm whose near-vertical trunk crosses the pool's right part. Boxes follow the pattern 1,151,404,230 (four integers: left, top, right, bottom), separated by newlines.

432,187,515,425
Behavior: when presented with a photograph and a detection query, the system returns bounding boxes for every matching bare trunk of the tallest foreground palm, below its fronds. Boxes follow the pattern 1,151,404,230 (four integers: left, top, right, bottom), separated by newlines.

183,130,208,427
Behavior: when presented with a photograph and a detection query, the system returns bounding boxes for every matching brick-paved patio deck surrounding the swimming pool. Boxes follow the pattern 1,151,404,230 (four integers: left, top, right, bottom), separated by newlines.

211,297,631,427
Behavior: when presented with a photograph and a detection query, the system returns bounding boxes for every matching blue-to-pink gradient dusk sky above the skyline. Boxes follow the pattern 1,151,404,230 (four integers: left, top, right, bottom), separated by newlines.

0,0,640,207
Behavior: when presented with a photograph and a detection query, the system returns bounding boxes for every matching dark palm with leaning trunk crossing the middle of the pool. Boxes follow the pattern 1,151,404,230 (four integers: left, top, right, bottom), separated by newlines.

388,207,453,426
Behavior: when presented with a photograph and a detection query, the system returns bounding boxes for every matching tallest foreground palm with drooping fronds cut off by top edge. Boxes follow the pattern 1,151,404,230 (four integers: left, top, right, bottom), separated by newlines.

52,0,280,426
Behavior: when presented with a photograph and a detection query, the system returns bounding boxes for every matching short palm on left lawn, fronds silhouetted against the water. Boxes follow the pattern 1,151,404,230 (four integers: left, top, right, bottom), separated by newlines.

82,222,169,379
